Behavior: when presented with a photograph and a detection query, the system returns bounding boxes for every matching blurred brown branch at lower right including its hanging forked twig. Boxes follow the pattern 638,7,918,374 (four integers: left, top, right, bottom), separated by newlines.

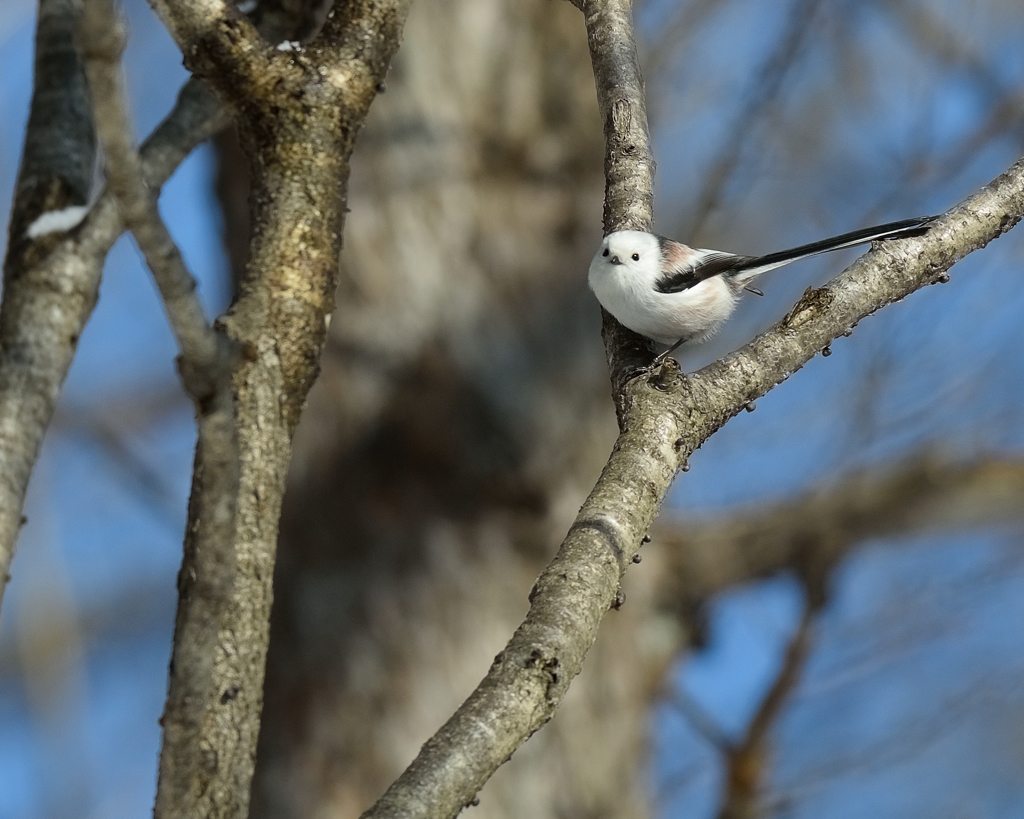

654,451,1024,819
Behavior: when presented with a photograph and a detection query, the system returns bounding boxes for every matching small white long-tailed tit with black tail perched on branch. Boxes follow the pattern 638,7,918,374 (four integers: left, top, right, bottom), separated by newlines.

589,216,937,364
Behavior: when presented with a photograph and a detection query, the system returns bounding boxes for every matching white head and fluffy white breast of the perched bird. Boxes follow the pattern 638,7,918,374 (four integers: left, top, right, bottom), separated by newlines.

589,230,736,344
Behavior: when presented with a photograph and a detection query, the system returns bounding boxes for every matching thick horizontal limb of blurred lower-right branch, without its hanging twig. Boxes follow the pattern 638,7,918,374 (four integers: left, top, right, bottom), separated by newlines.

657,452,1024,611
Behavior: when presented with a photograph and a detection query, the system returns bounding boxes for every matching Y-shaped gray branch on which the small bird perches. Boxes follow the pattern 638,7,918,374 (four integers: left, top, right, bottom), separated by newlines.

354,0,1024,819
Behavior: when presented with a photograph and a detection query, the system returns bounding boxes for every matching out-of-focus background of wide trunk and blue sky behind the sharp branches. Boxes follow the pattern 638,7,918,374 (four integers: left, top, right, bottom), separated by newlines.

0,0,1024,819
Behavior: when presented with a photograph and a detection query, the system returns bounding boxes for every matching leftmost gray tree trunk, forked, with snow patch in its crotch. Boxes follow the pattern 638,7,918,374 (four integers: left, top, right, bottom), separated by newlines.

0,0,323,614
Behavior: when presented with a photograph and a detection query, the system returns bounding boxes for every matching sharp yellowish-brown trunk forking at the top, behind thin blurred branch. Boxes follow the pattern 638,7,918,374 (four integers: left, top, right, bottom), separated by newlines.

139,0,409,817
